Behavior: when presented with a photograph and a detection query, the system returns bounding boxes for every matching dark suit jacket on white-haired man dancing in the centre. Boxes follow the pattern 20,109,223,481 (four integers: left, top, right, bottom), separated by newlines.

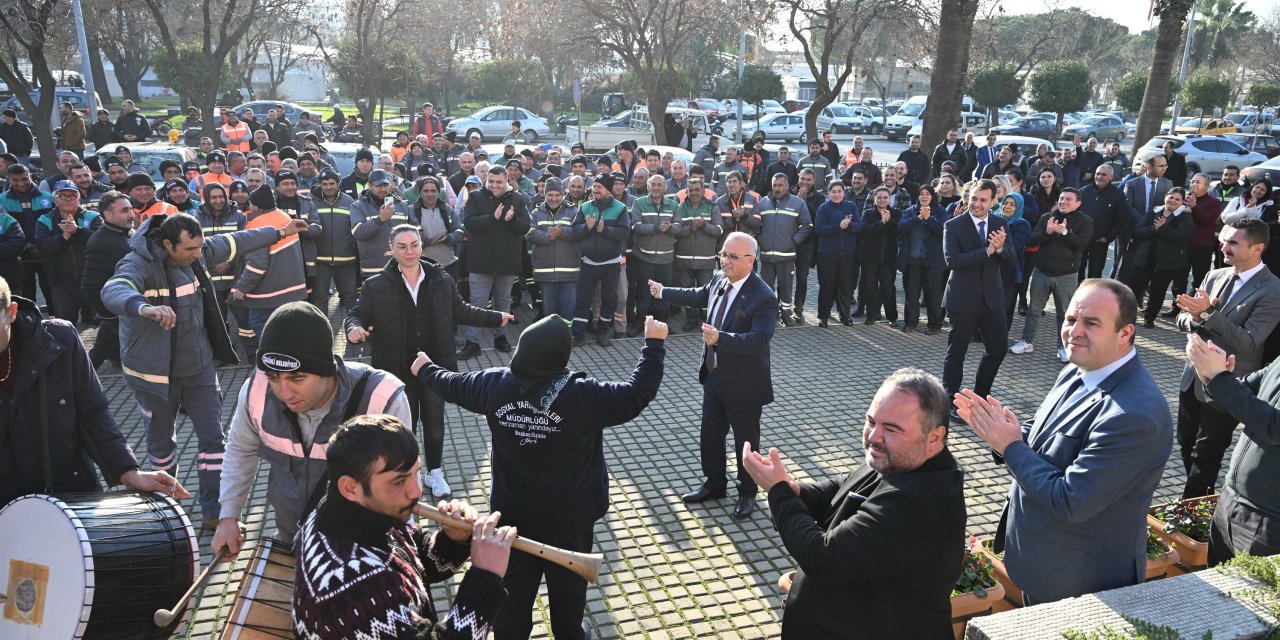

662,271,778,407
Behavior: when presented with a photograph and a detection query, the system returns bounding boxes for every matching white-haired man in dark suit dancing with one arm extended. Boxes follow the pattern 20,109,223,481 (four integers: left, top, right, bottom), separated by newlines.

649,232,778,520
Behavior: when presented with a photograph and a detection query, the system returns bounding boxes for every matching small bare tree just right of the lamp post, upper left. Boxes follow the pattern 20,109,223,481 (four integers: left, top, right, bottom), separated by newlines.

84,0,159,100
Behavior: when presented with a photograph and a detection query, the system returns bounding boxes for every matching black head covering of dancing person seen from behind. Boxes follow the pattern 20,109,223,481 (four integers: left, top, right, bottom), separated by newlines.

511,314,573,410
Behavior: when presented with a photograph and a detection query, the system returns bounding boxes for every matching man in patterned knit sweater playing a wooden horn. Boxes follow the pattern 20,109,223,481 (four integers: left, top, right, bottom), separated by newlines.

293,414,512,640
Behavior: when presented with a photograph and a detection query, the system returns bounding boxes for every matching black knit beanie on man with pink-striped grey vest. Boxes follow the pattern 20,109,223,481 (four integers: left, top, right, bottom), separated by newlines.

257,302,338,378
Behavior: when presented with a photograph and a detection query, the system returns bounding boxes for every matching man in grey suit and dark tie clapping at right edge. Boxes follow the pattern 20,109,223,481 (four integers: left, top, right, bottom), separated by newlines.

1174,218,1280,498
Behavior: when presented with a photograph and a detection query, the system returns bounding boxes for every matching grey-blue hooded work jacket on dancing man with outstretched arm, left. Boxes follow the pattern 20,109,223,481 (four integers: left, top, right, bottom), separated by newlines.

102,216,279,398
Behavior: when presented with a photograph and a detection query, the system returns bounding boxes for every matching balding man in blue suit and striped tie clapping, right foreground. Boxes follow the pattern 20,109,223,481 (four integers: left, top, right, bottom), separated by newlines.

955,279,1174,605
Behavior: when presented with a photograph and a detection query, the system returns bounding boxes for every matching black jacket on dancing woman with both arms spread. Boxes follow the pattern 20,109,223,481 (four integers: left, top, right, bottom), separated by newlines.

346,260,502,380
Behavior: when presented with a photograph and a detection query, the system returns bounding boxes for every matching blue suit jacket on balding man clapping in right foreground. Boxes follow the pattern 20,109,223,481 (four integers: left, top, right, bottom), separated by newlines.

1002,356,1174,603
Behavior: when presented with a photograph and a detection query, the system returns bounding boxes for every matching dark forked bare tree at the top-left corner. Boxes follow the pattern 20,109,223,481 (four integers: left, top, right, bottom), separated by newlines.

0,0,70,163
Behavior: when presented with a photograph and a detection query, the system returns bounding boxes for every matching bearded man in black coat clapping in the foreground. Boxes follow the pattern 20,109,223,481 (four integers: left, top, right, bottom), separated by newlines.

742,369,965,640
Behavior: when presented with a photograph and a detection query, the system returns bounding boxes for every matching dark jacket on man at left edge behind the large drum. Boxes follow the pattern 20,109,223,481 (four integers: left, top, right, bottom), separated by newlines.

0,297,138,503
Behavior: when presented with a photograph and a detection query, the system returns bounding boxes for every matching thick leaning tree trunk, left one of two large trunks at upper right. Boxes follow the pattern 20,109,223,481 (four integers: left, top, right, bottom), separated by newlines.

920,0,978,183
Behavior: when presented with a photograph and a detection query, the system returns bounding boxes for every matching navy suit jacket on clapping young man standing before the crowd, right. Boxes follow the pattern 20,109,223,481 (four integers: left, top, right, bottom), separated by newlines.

942,214,1018,314
